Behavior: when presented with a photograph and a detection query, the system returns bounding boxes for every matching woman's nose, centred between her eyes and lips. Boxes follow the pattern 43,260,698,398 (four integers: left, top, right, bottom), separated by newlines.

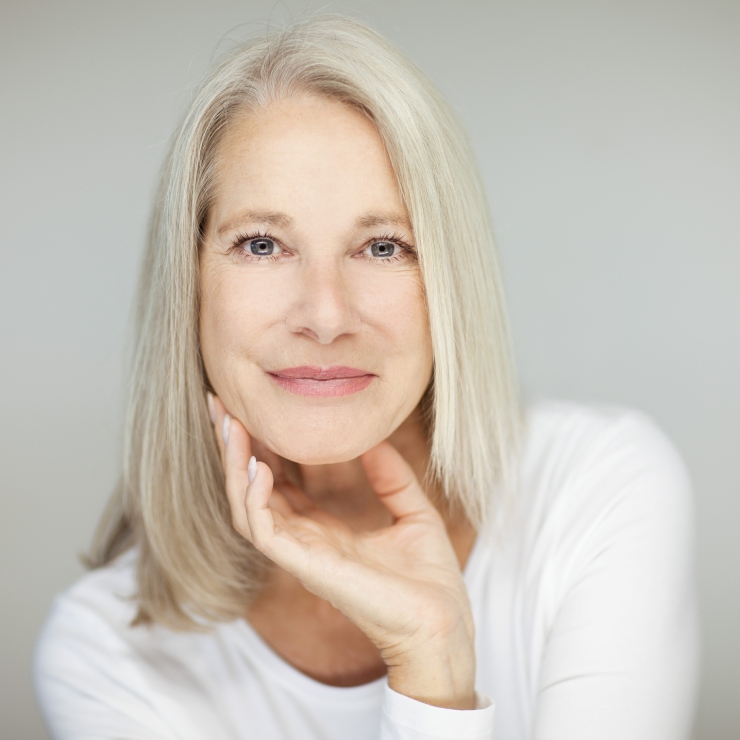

286,260,360,344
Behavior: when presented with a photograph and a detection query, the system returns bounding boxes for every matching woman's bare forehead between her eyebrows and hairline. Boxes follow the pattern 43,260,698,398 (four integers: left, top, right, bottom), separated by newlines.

213,96,406,228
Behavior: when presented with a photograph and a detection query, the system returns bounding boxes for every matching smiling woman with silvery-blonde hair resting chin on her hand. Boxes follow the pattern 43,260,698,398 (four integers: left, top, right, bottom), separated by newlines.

31,17,696,740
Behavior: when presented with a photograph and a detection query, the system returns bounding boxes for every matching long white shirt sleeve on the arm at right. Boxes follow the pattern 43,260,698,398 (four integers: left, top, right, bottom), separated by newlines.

532,412,698,740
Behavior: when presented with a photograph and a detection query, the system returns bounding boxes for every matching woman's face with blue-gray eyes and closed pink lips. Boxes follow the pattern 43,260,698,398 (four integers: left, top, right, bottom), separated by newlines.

200,96,432,464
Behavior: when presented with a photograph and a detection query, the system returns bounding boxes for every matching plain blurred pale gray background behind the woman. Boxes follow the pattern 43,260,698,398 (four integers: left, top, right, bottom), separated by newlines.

0,0,740,740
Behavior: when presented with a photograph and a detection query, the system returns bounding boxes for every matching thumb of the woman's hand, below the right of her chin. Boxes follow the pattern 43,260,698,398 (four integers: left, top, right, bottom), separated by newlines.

360,442,439,519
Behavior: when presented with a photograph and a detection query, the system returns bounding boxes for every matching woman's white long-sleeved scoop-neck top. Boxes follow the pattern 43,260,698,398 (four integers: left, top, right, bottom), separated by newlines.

35,402,698,740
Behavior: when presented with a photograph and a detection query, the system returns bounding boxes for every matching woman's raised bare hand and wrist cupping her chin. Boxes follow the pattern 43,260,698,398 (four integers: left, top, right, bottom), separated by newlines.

212,399,475,709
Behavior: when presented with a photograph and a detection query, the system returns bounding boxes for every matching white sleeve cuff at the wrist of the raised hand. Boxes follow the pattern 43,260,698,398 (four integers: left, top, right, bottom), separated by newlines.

380,684,494,740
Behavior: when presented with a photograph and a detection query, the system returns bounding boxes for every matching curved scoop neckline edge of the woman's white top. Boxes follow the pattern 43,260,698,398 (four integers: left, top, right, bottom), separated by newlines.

228,533,484,708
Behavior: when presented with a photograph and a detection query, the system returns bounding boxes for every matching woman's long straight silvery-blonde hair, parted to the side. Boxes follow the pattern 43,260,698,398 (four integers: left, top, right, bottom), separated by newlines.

89,15,520,629
